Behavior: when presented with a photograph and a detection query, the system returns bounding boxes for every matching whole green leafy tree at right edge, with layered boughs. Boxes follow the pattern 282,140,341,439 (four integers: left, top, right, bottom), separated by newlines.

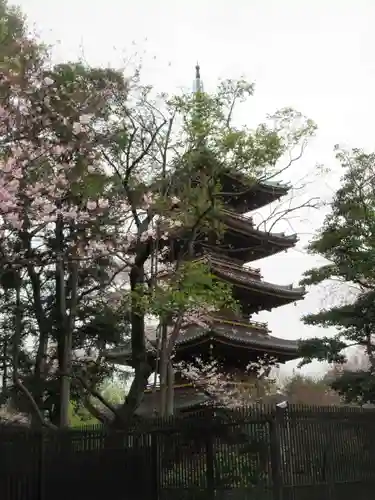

300,149,375,403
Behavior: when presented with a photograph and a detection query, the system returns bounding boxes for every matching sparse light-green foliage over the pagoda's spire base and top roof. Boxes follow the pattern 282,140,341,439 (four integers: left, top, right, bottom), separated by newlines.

169,80,316,184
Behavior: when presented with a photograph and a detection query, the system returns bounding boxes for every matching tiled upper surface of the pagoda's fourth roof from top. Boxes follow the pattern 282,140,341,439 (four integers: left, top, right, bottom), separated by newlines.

105,317,298,365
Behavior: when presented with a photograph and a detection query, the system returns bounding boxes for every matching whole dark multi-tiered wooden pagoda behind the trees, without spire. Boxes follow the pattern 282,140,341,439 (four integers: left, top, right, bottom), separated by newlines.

107,171,305,416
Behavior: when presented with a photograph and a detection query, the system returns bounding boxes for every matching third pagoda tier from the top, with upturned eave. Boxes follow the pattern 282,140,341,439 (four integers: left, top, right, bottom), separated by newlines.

159,254,305,316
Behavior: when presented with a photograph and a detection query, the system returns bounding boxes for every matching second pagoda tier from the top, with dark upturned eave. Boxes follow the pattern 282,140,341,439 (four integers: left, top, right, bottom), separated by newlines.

166,210,298,264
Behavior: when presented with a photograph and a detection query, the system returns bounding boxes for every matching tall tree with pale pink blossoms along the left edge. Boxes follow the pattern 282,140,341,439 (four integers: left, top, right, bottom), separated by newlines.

0,2,131,425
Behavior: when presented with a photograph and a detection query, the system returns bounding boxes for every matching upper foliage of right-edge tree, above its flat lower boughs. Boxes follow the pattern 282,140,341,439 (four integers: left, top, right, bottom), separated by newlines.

305,149,375,286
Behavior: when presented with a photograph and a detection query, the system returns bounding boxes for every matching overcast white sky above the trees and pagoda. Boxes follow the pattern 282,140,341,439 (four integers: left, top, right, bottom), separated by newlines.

15,0,375,371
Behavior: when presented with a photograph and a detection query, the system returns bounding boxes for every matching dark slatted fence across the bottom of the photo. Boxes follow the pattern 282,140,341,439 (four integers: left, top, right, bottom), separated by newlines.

0,406,375,500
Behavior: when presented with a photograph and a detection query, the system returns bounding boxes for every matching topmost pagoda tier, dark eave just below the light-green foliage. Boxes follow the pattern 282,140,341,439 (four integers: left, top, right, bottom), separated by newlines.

220,171,290,213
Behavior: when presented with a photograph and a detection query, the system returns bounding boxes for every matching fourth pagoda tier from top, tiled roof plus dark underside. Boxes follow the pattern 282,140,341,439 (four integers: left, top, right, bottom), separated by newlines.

105,316,298,370
